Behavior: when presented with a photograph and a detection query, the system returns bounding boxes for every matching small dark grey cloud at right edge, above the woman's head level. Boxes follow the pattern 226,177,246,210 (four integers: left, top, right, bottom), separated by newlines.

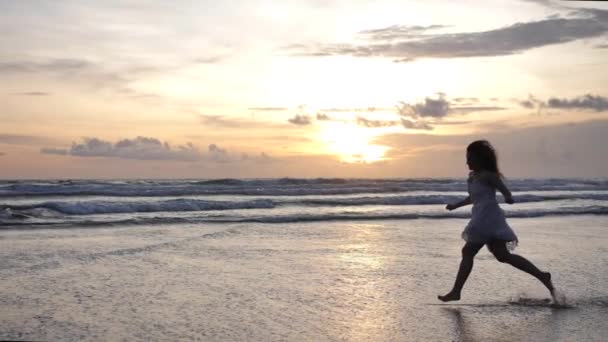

519,94,608,113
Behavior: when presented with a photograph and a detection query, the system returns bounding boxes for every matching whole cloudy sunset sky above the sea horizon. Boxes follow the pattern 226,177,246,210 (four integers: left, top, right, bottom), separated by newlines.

0,0,608,179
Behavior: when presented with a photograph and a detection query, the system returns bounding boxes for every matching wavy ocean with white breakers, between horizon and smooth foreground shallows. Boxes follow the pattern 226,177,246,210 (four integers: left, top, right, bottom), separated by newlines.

0,178,608,228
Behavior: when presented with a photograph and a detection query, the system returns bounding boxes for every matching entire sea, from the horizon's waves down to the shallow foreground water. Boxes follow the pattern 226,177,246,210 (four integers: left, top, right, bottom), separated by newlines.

0,178,608,341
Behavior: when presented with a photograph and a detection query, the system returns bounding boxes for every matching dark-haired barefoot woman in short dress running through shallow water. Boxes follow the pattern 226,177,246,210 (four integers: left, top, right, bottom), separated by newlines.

437,140,554,302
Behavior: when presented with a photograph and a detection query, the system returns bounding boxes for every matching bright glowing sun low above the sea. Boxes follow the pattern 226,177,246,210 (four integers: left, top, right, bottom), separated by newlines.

319,122,389,163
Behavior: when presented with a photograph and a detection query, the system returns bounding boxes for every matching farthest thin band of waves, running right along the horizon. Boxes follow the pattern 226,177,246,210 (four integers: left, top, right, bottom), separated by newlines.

0,178,608,197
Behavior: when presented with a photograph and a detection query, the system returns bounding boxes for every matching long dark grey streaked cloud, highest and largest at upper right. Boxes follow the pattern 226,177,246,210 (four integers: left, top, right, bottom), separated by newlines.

286,9,608,61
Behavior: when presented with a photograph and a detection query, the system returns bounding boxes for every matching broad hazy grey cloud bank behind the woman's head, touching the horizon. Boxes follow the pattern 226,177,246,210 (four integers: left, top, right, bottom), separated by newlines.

373,120,608,178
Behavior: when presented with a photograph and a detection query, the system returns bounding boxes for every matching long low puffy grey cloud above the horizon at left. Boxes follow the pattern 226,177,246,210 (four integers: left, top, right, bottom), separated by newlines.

47,137,202,161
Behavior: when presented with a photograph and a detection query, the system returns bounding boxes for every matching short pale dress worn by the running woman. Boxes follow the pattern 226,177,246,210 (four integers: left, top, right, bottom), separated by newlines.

462,172,517,249
